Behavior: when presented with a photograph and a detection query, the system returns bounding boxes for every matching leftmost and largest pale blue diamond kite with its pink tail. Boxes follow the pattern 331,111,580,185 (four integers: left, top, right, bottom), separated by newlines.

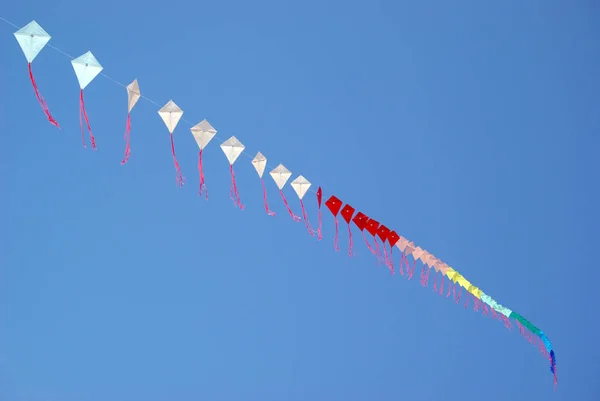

14,21,60,128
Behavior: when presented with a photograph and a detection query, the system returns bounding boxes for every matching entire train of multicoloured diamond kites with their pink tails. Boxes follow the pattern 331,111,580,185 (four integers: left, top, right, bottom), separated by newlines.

8,21,558,386
